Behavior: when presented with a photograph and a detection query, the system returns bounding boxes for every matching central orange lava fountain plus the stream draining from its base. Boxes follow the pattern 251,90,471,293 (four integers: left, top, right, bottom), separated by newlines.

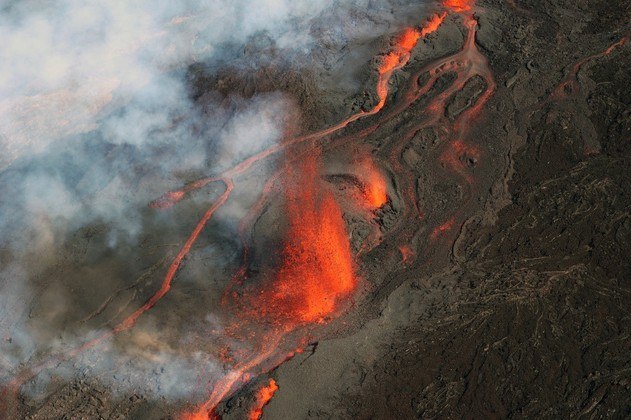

185,149,356,418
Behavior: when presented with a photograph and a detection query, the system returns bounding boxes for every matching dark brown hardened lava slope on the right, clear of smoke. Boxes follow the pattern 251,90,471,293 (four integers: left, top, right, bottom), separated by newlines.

251,0,631,418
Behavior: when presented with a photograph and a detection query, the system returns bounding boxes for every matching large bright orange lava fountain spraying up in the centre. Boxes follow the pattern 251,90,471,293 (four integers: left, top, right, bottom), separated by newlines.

258,156,356,322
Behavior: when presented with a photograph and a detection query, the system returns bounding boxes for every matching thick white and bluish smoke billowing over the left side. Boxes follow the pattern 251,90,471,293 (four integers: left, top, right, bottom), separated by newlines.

0,0,430,406
